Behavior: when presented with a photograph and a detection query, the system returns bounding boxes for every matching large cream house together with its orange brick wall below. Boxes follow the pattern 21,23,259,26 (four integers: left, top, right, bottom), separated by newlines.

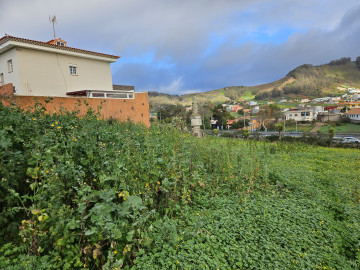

0,36,150,126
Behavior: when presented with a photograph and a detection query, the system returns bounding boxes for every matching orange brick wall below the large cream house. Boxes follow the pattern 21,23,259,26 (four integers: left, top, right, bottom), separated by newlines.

0,84,150,127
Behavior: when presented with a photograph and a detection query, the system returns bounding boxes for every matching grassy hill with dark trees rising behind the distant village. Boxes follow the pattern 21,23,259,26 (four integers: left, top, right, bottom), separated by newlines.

150,57,360,107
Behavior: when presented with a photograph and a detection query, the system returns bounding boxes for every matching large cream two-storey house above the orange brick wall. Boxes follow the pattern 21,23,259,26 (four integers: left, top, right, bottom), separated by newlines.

0,35,134,98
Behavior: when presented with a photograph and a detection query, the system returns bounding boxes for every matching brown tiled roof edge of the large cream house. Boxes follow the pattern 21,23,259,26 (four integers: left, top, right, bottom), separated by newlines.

0,36,120,59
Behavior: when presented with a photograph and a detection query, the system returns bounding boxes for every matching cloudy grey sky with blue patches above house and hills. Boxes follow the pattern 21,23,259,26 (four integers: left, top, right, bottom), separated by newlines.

0,0,360,94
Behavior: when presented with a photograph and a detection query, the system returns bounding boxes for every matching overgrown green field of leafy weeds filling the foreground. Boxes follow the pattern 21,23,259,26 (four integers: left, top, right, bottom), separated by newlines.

0,102,360,269
